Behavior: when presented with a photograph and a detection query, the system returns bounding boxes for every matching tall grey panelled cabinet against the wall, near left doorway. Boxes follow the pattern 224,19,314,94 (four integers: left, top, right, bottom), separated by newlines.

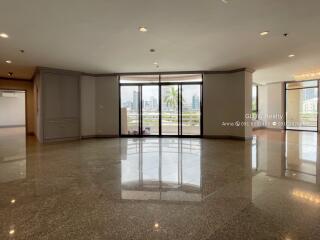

40,71,80,142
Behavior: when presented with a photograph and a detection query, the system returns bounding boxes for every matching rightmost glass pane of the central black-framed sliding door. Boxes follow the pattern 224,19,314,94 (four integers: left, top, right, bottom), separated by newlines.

181,84,201,135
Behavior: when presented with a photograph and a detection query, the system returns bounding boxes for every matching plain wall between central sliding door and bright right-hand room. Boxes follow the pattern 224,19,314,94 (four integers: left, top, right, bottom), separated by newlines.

203,71,252,138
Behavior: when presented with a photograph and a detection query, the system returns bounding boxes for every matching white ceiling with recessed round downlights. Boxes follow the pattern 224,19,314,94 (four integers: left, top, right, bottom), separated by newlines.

0,0,320,83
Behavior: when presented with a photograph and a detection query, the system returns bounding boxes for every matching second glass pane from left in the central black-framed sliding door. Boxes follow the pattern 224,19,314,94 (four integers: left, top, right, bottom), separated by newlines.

142,85,159,135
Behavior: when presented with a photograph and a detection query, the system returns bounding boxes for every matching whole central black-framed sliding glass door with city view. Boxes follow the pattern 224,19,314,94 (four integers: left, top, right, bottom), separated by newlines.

120,74,202,136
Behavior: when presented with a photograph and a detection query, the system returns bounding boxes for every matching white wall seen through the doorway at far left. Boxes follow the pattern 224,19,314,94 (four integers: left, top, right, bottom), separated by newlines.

0,91,26,127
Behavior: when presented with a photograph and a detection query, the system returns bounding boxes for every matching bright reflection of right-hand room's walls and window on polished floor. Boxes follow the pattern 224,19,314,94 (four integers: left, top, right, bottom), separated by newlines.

252,131,320,183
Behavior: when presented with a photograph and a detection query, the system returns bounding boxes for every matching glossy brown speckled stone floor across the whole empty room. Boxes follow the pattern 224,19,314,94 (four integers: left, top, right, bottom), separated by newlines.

0,126,320,240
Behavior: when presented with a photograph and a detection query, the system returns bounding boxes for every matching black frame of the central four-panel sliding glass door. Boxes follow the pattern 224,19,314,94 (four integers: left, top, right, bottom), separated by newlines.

118,74,203,138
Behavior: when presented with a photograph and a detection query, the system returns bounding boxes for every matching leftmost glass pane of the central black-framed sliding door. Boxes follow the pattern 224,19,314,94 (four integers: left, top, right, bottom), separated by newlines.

121,86,140,135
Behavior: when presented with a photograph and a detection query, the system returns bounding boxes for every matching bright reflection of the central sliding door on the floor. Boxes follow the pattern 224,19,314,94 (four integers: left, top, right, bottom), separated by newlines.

121,138,201,201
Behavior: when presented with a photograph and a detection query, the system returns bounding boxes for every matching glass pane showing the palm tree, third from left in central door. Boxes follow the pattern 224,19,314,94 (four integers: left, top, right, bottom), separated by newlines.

161,85,179,135
